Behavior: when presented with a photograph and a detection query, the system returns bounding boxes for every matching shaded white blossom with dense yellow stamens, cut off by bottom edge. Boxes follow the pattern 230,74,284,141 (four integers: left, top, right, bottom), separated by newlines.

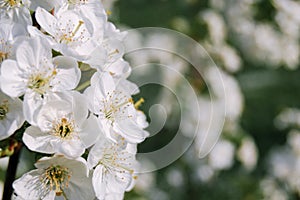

13,156,95,200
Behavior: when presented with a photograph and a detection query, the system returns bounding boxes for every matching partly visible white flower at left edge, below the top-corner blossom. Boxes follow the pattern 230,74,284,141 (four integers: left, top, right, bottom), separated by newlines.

0,21,26,64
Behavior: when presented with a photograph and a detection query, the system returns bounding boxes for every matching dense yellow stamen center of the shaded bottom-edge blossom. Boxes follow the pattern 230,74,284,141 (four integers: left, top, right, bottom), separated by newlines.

40,165,71,196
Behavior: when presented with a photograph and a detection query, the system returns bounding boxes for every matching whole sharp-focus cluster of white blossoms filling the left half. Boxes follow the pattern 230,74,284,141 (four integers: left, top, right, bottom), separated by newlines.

0,0,148,200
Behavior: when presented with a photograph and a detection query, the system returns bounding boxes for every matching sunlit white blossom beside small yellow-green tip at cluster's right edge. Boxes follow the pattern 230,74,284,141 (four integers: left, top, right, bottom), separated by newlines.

85,73,148,143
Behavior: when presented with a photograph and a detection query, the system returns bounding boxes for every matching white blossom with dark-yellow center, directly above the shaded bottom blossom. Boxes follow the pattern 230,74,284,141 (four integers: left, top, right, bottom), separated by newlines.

23,92,100,158
